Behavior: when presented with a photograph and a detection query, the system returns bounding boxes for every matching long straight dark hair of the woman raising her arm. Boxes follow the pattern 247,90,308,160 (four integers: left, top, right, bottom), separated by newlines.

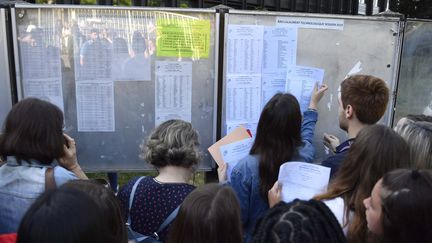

250,93,302,201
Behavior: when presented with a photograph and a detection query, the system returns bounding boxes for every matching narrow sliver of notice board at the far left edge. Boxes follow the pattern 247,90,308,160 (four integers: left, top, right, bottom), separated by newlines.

0,8,12,127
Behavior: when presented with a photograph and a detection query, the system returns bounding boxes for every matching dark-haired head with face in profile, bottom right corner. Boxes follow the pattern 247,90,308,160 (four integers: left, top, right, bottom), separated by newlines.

364,169,432,243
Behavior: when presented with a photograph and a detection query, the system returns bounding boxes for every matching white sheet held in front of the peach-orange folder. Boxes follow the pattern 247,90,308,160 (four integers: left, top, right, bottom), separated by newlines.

219,138,254,181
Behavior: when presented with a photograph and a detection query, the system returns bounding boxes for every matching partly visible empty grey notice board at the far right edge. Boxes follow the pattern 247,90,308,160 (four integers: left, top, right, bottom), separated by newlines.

393,19,432,125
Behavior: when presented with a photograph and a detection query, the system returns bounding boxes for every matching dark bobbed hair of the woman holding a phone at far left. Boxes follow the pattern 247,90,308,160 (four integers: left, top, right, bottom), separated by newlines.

0,98,64,165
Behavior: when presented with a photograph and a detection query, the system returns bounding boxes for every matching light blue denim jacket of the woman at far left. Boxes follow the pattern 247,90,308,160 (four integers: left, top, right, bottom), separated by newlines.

0,156,78,234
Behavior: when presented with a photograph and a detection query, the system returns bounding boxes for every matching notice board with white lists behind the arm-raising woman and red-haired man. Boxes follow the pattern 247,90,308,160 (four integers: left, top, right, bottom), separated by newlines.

221,10,403,162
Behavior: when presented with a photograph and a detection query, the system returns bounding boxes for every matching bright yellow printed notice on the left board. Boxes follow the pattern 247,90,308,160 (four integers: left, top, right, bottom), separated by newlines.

156,19,210,59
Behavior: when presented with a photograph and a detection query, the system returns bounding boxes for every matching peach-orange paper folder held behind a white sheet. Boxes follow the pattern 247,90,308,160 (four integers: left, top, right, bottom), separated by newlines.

208,126,251,166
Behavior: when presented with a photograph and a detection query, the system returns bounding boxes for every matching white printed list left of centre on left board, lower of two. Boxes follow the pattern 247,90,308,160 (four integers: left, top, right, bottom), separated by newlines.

76,80,115,132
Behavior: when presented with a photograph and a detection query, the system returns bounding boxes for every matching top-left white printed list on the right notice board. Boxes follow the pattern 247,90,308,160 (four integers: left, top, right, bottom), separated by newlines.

227,25,264,74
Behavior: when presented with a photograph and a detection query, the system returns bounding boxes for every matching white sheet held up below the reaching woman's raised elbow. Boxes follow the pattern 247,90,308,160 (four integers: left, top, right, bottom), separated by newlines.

278,162,330,202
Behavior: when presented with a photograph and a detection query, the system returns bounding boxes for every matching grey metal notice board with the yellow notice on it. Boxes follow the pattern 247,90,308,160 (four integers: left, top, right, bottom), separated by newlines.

11,4,219,171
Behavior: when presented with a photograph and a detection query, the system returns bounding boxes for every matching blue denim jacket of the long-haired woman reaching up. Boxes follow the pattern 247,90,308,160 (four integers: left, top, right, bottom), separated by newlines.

231,110,318,242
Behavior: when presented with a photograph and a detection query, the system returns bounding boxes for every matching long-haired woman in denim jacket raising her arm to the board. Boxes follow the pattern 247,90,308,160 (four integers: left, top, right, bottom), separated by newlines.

226,85,328,242
